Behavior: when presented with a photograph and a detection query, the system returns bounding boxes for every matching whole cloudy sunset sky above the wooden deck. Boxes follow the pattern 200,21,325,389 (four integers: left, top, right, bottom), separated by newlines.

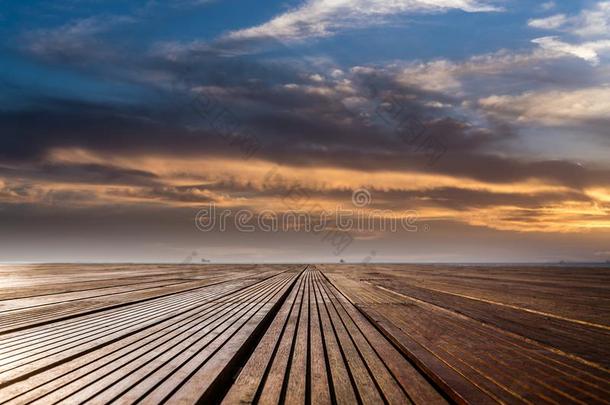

0,0,610,263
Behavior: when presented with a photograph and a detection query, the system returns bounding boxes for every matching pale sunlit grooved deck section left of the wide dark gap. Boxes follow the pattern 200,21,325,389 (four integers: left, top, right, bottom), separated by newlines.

0,266,302,403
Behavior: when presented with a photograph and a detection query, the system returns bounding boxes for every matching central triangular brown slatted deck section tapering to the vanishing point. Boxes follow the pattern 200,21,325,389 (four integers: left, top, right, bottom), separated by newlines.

224,269,446,404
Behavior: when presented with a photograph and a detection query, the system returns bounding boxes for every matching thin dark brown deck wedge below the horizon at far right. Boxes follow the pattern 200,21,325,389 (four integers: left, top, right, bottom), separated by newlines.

325,265,610,327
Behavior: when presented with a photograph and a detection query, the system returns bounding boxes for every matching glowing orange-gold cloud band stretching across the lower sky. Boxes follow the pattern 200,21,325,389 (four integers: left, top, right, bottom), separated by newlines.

0,151,610,232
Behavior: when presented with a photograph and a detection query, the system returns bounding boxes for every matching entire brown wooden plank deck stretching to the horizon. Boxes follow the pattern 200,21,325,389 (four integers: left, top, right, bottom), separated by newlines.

0,265,610,404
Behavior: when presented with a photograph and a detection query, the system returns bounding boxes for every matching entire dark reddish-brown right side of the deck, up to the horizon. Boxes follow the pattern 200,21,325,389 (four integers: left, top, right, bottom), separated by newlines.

321,265,610,403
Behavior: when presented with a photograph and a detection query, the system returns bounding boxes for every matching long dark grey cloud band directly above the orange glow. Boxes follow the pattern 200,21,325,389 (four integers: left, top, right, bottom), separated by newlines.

0,87,610,193
